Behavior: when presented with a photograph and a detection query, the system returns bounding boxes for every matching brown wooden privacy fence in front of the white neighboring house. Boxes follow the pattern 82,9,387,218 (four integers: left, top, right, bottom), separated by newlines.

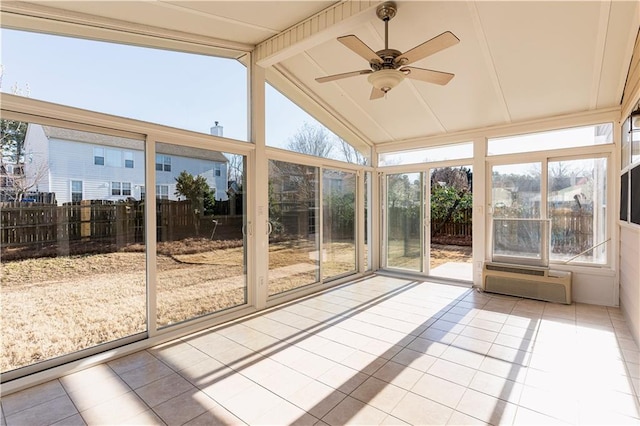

0,200,194,247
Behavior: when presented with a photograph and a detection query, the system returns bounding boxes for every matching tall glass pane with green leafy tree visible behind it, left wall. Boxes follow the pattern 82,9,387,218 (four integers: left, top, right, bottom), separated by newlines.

156,143,247,327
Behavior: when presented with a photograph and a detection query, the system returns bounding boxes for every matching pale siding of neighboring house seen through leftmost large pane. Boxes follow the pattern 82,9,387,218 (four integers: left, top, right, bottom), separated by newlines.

49,138,145,204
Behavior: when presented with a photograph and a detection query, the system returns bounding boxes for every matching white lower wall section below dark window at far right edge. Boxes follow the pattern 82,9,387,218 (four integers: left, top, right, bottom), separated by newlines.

620,226,640,344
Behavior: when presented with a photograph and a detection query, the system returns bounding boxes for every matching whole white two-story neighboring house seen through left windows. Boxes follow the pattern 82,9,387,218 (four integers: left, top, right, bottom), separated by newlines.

25,124,228,204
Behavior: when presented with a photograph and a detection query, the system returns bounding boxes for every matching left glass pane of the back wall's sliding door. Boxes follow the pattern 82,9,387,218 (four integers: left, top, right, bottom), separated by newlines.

386,173,424,271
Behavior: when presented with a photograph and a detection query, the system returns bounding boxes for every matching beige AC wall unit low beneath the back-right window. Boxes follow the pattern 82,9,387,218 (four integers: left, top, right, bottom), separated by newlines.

482,262,571,305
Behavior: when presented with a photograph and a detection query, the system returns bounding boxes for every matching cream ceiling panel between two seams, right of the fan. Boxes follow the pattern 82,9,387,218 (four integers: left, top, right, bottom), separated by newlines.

477,2,601,121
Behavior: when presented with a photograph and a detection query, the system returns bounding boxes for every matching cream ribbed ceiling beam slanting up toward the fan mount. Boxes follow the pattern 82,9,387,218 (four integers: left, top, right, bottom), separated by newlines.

254,0,380,68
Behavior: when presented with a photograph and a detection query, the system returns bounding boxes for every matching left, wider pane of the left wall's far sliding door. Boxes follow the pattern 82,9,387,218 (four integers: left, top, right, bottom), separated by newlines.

268,160,320,296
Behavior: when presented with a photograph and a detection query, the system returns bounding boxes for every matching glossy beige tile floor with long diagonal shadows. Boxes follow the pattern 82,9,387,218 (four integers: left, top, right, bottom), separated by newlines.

0,276,640,425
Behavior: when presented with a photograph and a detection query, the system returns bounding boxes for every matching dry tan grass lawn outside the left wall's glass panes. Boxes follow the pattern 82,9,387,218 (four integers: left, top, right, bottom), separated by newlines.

0,240,470,372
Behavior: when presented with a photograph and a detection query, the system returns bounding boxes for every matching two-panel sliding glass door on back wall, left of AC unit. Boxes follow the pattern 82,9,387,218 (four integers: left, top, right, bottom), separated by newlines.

383,166,473,281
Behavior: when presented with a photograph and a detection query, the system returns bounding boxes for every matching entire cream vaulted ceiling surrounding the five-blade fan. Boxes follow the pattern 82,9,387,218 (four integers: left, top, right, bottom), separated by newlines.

6,0,640,144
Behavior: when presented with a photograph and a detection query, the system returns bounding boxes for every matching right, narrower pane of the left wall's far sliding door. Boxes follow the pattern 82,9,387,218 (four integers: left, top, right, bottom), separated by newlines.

322,169,356,279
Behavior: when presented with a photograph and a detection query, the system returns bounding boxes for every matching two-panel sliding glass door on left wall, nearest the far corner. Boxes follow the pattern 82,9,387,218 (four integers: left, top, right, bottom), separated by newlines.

268,160,357,296
